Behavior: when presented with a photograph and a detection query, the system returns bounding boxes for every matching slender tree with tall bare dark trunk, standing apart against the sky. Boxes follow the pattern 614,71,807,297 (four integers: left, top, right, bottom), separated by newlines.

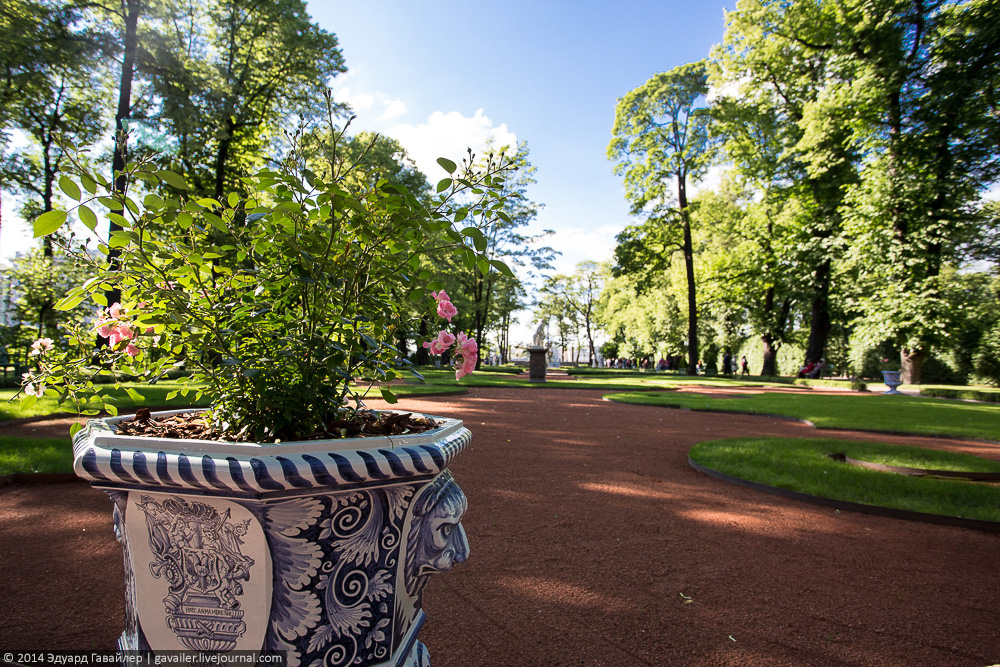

608,61,714,374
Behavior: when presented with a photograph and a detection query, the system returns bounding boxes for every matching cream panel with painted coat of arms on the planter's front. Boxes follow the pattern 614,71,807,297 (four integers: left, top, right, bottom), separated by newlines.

127,492,270,651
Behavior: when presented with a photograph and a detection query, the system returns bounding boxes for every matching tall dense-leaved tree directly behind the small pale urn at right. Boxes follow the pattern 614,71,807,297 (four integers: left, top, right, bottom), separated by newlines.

828,0,1000,383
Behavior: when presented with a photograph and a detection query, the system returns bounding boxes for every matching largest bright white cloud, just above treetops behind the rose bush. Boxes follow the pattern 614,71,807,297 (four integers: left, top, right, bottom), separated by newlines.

386,109,517,182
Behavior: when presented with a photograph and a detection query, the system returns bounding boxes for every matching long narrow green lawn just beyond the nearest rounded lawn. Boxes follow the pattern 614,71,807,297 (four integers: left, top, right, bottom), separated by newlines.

605,392,1000,441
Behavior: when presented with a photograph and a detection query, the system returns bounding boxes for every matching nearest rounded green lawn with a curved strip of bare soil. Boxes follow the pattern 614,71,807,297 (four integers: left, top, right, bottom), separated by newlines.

690,438,1000,521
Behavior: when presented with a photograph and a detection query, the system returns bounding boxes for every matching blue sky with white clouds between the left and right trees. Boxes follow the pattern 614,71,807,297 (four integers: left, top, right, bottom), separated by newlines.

309,0,733,271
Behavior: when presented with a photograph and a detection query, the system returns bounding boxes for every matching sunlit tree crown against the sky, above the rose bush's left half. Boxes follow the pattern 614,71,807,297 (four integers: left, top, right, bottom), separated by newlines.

138,0,345,199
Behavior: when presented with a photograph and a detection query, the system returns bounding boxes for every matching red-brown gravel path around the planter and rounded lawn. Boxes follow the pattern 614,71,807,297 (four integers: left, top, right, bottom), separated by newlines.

0,389,1000,667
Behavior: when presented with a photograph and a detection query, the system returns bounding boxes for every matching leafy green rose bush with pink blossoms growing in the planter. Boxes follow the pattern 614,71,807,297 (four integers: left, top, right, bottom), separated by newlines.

23,132,512,441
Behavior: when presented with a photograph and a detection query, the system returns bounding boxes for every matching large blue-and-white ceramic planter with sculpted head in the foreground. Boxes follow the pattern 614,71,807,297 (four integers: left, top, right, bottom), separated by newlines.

73,411,472,667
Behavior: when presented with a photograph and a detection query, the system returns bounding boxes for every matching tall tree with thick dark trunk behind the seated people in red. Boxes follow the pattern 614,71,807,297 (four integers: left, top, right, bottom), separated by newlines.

712,0,858,365
